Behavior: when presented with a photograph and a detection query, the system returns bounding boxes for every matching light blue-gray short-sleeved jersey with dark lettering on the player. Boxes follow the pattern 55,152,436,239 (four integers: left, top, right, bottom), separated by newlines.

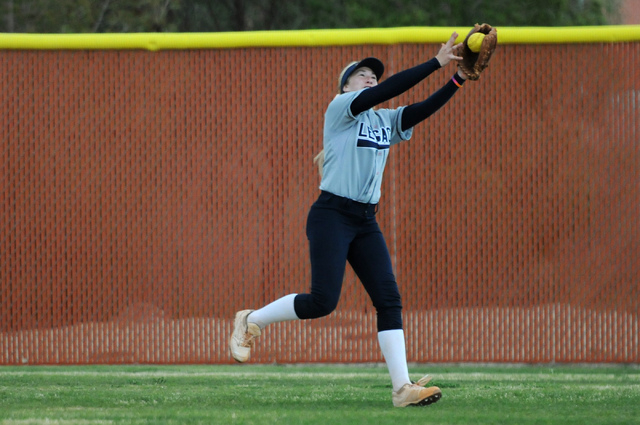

320,89,413,204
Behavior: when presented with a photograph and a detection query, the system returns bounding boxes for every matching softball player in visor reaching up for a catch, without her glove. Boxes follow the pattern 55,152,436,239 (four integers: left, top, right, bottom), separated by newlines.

229,32,466,407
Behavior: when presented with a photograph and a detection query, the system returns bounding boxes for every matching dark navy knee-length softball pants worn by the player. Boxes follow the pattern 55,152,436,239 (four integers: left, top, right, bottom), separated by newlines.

294,192,402,331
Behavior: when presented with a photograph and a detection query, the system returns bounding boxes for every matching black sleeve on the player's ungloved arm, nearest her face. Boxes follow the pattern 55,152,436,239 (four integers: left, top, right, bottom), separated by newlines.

351,58,440,116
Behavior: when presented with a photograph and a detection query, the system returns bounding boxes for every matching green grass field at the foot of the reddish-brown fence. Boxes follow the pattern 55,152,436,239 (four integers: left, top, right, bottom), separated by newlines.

0,365,640,425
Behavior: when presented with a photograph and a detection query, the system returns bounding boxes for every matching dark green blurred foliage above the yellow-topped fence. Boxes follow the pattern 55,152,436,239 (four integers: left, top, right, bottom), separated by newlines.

0,0,621,33
